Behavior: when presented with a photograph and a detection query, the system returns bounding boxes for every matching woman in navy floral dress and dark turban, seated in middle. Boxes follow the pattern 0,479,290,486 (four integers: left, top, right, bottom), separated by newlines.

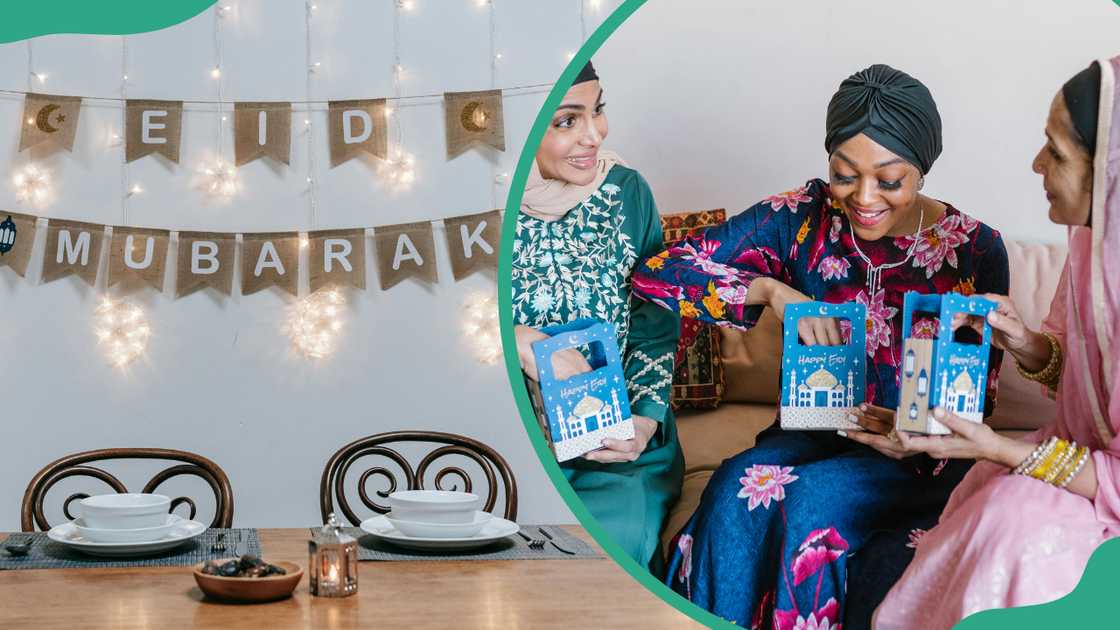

634,65,1008,630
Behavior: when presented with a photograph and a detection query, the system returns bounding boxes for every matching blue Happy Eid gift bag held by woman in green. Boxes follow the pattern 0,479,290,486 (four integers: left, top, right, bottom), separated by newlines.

525,319,634,462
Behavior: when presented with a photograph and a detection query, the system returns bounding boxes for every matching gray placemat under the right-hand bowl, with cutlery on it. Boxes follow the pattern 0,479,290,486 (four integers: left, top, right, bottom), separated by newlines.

324,525,606,560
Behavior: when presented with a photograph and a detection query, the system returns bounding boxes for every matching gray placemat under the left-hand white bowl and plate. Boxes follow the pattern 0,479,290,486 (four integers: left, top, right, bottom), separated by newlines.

0,528,261,571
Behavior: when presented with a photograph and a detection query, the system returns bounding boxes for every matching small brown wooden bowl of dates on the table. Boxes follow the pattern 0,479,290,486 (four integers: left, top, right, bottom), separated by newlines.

195,555,304,603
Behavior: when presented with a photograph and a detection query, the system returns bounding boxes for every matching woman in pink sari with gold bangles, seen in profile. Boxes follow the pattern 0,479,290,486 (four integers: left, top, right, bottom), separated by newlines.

874,57,1120,629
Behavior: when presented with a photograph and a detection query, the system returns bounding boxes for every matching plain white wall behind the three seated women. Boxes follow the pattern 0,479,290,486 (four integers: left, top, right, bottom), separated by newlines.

596,0,1120,242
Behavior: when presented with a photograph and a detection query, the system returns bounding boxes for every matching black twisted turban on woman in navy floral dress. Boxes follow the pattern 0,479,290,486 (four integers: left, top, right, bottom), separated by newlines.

824,64,941,175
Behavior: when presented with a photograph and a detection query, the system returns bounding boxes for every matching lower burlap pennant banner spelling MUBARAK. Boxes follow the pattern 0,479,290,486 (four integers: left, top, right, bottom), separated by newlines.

0,211,502,297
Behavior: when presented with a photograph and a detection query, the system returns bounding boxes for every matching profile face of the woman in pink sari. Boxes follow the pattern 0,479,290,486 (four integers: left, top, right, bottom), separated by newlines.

1030,92,1093,225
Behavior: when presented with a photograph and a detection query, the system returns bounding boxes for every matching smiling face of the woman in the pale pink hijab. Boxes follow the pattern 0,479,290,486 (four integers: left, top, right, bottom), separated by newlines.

536,81,607,186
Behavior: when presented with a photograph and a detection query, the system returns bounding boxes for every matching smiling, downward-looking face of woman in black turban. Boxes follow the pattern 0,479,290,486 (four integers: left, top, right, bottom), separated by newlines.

829,133,930,241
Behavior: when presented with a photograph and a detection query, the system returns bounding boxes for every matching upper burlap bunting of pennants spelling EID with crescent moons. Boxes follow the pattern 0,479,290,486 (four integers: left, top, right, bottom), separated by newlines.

19,90,505,167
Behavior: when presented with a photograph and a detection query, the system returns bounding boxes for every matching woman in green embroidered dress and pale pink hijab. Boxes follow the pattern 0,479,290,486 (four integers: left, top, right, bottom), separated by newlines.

513,63,683,573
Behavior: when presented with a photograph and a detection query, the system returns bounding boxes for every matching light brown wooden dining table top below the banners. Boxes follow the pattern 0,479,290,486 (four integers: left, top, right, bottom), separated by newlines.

0,526,699,630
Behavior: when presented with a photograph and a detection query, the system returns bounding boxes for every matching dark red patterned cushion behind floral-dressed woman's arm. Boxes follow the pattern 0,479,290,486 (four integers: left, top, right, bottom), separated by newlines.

661,209,727,409
